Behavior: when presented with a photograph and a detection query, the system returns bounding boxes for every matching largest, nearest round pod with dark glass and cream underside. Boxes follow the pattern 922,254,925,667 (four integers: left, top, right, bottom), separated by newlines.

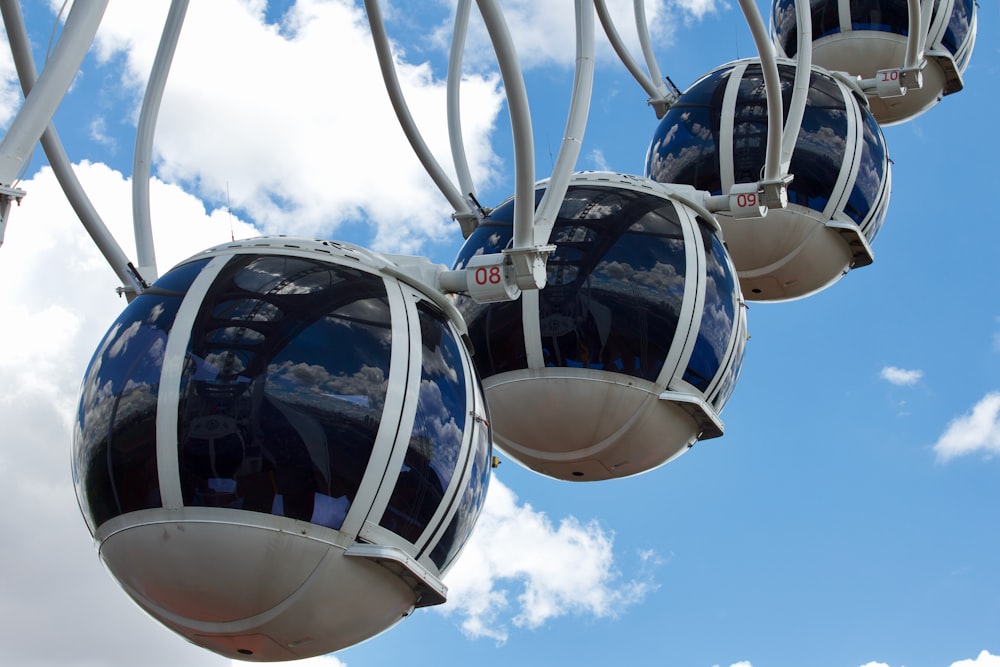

73,238,492,660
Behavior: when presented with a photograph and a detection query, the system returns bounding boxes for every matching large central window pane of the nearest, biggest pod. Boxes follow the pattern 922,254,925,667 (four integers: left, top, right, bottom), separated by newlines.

178,255,392,528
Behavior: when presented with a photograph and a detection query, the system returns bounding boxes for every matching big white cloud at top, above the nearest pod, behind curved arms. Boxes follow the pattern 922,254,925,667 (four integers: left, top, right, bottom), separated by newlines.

88,0,502,253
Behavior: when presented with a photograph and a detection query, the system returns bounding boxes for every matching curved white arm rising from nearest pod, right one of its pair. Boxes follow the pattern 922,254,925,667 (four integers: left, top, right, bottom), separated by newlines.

132,0,188,282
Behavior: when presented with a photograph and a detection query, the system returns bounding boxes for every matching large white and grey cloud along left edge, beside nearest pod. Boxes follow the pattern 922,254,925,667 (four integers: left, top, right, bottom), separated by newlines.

0,163,252,667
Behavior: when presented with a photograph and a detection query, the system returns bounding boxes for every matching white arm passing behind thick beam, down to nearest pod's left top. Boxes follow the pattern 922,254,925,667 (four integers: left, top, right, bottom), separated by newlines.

0,0,146,299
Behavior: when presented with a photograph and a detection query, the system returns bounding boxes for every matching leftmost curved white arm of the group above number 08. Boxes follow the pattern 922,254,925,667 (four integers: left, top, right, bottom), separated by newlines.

365,0,475,227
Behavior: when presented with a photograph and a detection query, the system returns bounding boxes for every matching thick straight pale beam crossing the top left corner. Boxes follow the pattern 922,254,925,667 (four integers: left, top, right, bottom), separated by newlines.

0,0,108,185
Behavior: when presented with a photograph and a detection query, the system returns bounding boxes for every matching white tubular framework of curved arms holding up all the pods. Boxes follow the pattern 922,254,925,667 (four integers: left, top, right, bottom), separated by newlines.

0,0,968,306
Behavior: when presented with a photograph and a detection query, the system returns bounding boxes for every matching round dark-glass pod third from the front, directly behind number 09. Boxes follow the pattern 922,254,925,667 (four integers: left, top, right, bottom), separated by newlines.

645,59,890,301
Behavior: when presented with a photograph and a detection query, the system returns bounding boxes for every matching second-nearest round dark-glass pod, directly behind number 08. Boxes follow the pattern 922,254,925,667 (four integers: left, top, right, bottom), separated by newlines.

455,172,746,481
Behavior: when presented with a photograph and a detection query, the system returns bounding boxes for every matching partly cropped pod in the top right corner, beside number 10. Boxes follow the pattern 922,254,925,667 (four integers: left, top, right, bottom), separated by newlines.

771,0,976,125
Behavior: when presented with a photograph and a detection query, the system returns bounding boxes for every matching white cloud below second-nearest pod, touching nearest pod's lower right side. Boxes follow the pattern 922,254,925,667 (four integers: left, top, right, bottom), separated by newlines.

439,477,655,642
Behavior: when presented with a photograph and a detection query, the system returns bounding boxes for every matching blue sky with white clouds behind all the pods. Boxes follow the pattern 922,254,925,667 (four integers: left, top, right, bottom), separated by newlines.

0,0,1000,667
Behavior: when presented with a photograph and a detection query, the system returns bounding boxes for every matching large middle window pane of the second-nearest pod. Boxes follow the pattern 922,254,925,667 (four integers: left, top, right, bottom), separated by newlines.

539,187,686,381
